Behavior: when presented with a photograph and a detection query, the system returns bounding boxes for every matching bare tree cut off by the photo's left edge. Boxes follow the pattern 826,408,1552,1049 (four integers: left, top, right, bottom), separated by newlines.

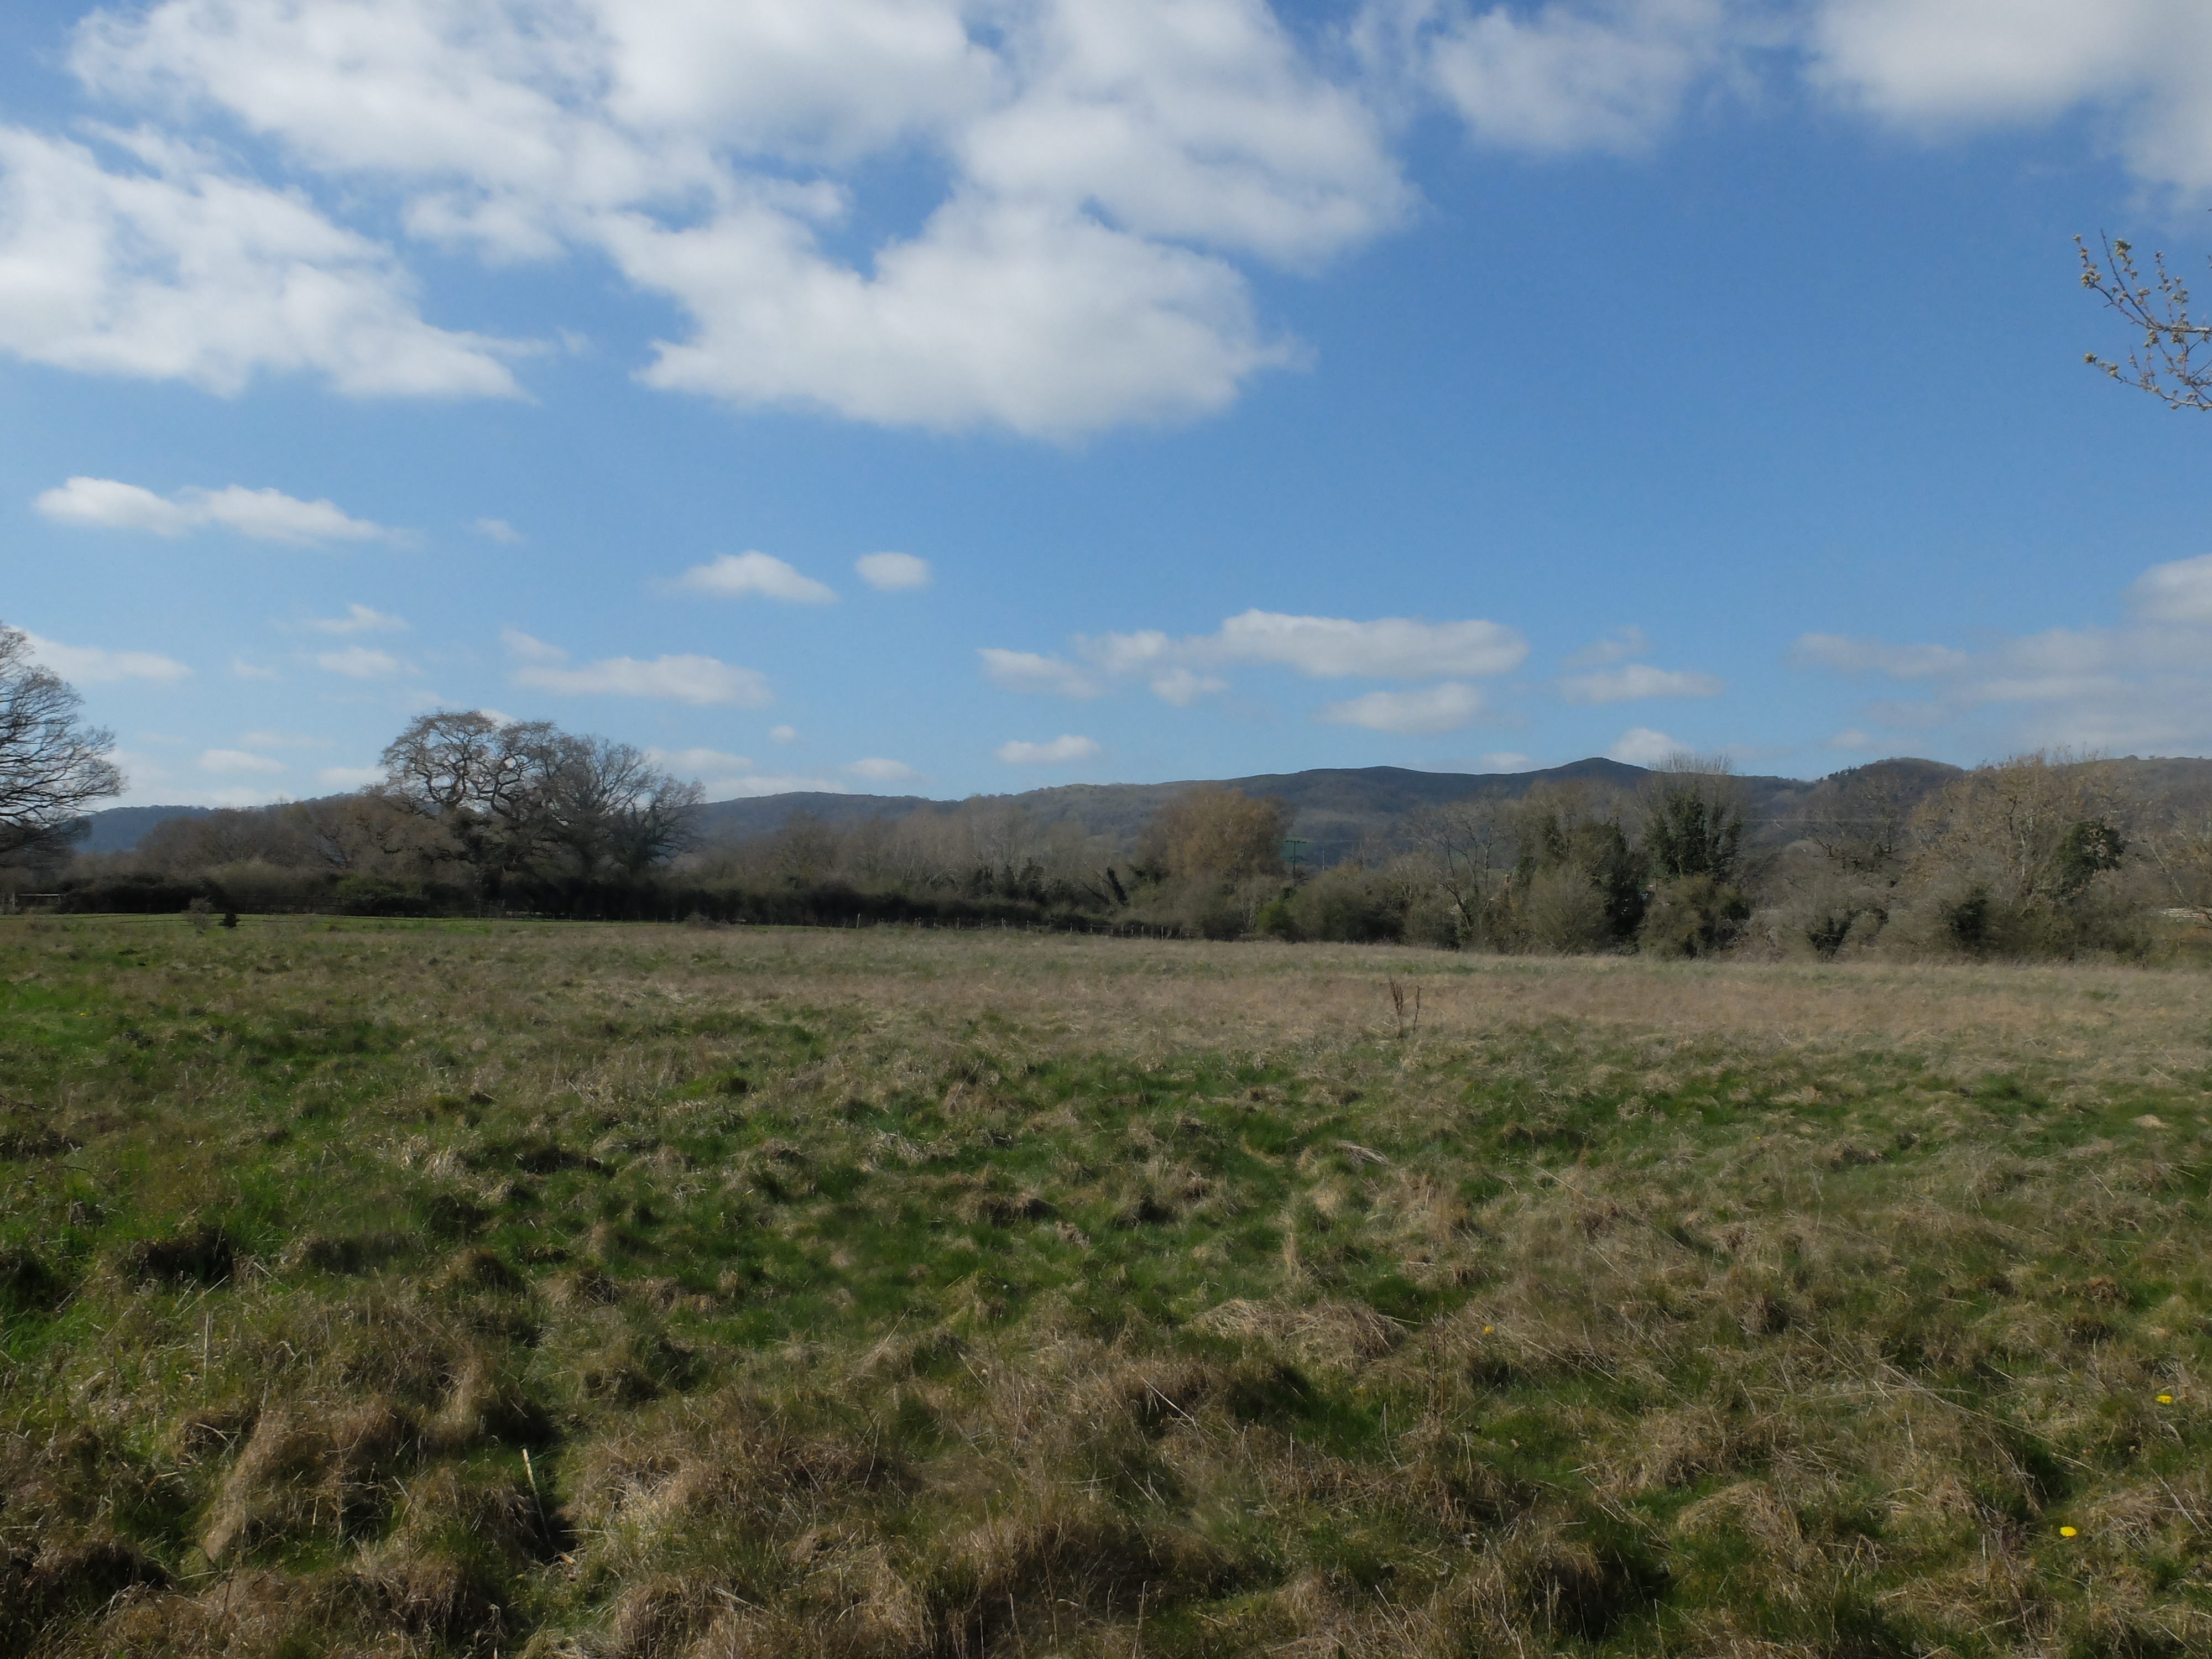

0,622,124,860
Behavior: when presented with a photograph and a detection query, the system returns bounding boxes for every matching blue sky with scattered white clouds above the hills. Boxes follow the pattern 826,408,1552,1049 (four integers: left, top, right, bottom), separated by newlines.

0,0,2212,805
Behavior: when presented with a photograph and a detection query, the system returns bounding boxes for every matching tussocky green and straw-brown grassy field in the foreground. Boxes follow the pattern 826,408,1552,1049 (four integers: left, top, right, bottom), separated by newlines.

0,918,2212,1659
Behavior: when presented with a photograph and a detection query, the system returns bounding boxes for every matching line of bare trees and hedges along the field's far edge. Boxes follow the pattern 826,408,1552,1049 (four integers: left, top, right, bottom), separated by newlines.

0,626,2212,960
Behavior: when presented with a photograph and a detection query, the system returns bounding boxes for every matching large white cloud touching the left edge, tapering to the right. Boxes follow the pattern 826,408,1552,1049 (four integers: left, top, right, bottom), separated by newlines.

0,126,515,396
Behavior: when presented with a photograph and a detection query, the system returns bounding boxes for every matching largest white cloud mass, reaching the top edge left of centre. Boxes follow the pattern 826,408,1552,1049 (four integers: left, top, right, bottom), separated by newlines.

60,0,1413,438
